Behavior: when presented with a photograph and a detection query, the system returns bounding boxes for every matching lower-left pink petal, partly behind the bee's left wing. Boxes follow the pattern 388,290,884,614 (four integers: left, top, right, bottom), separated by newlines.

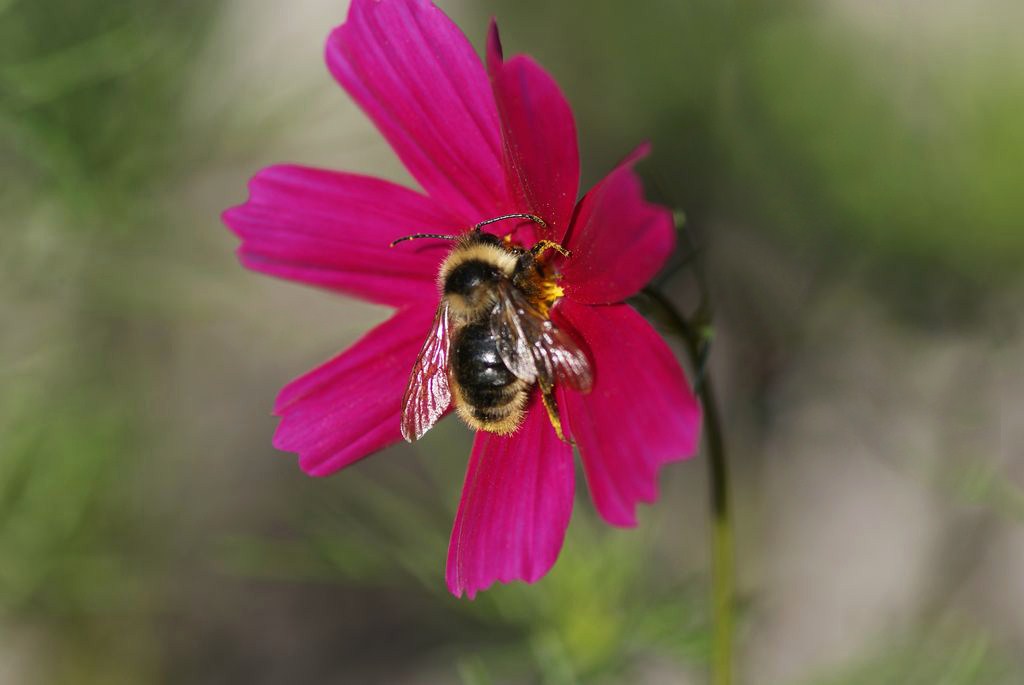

273,301,436,476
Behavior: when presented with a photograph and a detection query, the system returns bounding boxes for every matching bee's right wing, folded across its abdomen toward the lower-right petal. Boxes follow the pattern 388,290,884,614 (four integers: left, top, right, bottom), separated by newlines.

490,281,594,392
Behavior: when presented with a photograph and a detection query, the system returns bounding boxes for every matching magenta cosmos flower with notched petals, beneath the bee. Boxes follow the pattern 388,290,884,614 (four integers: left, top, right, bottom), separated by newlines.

223,0,699,597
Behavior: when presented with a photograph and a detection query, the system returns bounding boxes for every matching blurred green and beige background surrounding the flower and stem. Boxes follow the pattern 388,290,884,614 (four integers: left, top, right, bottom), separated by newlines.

0,0,1024,685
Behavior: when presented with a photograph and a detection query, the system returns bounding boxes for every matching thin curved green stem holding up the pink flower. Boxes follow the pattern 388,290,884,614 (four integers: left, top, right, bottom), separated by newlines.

643,288,734,685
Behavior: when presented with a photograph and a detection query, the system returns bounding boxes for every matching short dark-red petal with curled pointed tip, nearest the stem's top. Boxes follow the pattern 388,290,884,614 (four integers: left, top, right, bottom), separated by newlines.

562,145,676,304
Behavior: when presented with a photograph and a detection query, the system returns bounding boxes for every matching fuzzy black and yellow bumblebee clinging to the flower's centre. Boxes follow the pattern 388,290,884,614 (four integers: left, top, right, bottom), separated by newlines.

391,214,593,442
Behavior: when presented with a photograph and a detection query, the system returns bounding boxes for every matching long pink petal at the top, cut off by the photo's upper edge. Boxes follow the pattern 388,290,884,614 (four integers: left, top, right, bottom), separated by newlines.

327,0,508,225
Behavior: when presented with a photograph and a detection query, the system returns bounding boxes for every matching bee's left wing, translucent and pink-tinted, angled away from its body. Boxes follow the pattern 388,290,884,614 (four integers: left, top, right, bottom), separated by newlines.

401,301,452,442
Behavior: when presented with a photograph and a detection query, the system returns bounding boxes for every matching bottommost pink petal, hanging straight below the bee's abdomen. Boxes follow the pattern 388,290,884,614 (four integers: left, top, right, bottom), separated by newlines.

446,397,573,599
